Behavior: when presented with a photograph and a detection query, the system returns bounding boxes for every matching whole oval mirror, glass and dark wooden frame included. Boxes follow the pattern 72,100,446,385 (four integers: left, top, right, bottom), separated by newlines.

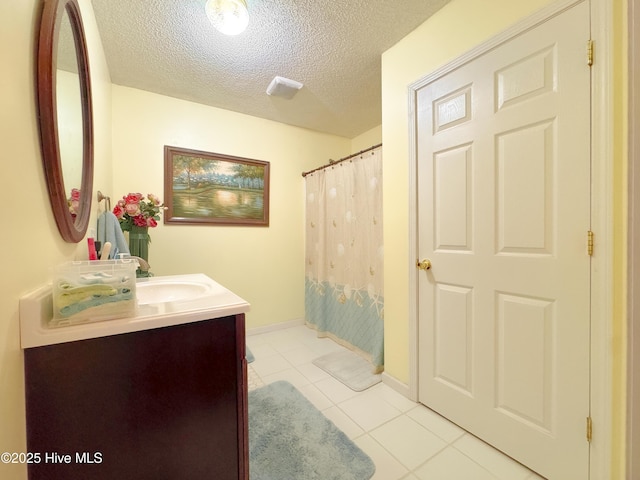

36,0,93,243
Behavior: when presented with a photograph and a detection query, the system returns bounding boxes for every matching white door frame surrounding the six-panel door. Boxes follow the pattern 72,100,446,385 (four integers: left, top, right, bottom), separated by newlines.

408,0,614,479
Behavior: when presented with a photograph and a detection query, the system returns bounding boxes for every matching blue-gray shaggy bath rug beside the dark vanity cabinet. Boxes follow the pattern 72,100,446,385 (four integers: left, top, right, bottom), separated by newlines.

249,381,375,480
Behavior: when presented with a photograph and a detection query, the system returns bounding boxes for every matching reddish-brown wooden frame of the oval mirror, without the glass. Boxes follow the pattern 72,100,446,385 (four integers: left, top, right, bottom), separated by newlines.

36,0,93,243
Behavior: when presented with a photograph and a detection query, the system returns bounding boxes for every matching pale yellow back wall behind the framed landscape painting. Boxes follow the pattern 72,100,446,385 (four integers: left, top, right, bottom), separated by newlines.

110,85,351,328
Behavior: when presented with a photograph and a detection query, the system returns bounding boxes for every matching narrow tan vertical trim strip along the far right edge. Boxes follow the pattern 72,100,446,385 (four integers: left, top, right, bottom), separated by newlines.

626,1,640,480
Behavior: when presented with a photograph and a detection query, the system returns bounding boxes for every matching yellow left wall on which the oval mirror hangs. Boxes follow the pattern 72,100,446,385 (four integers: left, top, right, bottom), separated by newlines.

0,0,110,480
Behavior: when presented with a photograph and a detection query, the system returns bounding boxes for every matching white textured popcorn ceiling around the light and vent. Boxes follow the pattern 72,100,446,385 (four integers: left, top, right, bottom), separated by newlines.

92,0,449,138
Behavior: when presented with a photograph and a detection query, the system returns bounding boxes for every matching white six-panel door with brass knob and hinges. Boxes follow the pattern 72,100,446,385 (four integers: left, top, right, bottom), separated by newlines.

416,1,591,480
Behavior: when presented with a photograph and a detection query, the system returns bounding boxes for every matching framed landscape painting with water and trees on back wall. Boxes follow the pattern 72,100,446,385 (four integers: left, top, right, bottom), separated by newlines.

164,146,269,226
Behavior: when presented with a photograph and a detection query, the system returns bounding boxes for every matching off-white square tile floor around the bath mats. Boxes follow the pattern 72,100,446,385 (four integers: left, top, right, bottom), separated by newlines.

247,325,542,480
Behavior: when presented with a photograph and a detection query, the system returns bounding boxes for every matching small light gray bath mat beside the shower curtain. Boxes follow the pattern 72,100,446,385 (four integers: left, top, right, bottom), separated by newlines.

312,350,381,392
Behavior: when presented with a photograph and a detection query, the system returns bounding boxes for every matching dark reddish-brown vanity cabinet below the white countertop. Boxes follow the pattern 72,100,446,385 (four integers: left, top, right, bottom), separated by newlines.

24,313,249,480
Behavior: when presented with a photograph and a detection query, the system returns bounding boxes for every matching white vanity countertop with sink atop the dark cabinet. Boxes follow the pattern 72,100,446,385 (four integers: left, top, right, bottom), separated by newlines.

20,273,250,349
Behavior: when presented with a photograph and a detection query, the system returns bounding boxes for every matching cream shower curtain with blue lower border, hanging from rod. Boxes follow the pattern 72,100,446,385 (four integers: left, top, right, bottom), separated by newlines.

305,147,384,372
